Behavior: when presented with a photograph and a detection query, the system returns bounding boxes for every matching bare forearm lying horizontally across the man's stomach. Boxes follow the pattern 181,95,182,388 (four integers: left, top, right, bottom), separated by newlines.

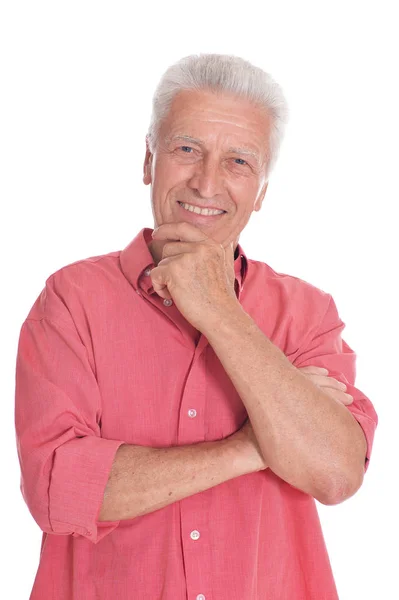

99,438,251,521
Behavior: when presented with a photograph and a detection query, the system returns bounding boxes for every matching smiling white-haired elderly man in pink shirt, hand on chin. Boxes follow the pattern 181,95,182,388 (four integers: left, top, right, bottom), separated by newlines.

16,55,377,600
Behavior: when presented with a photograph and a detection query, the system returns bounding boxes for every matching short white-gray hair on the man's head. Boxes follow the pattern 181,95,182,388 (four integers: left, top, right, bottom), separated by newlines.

147,54,288,178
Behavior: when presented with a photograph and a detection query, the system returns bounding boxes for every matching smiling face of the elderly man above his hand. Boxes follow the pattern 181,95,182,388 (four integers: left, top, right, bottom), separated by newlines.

143,90,270,252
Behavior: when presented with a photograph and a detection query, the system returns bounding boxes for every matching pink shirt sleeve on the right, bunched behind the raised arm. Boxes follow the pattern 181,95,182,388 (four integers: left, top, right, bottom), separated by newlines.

292,294,378,472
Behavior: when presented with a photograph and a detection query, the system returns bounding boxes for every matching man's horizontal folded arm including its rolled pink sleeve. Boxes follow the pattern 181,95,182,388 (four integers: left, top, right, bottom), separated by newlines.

15,278,263,543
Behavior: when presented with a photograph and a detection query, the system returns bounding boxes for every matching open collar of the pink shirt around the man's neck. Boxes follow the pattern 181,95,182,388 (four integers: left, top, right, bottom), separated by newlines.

120,227,248,299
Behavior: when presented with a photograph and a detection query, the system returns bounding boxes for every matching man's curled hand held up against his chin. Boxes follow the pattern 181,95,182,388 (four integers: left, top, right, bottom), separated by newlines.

150,222,240,333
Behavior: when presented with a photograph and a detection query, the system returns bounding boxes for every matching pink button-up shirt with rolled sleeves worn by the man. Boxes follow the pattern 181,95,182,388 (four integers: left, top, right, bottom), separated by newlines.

15,228,377,600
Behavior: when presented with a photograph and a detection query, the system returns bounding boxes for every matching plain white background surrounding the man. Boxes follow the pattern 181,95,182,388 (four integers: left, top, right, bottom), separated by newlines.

0,0,399,600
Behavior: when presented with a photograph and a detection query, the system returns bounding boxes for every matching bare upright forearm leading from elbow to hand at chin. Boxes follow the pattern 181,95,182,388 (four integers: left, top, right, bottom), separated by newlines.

205,309,366,503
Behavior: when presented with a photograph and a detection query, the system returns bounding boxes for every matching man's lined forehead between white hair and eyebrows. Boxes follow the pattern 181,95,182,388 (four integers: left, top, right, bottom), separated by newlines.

161,90,271,150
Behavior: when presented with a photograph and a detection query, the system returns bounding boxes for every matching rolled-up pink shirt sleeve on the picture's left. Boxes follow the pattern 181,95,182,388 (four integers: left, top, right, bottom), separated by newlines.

15,276,125,543
